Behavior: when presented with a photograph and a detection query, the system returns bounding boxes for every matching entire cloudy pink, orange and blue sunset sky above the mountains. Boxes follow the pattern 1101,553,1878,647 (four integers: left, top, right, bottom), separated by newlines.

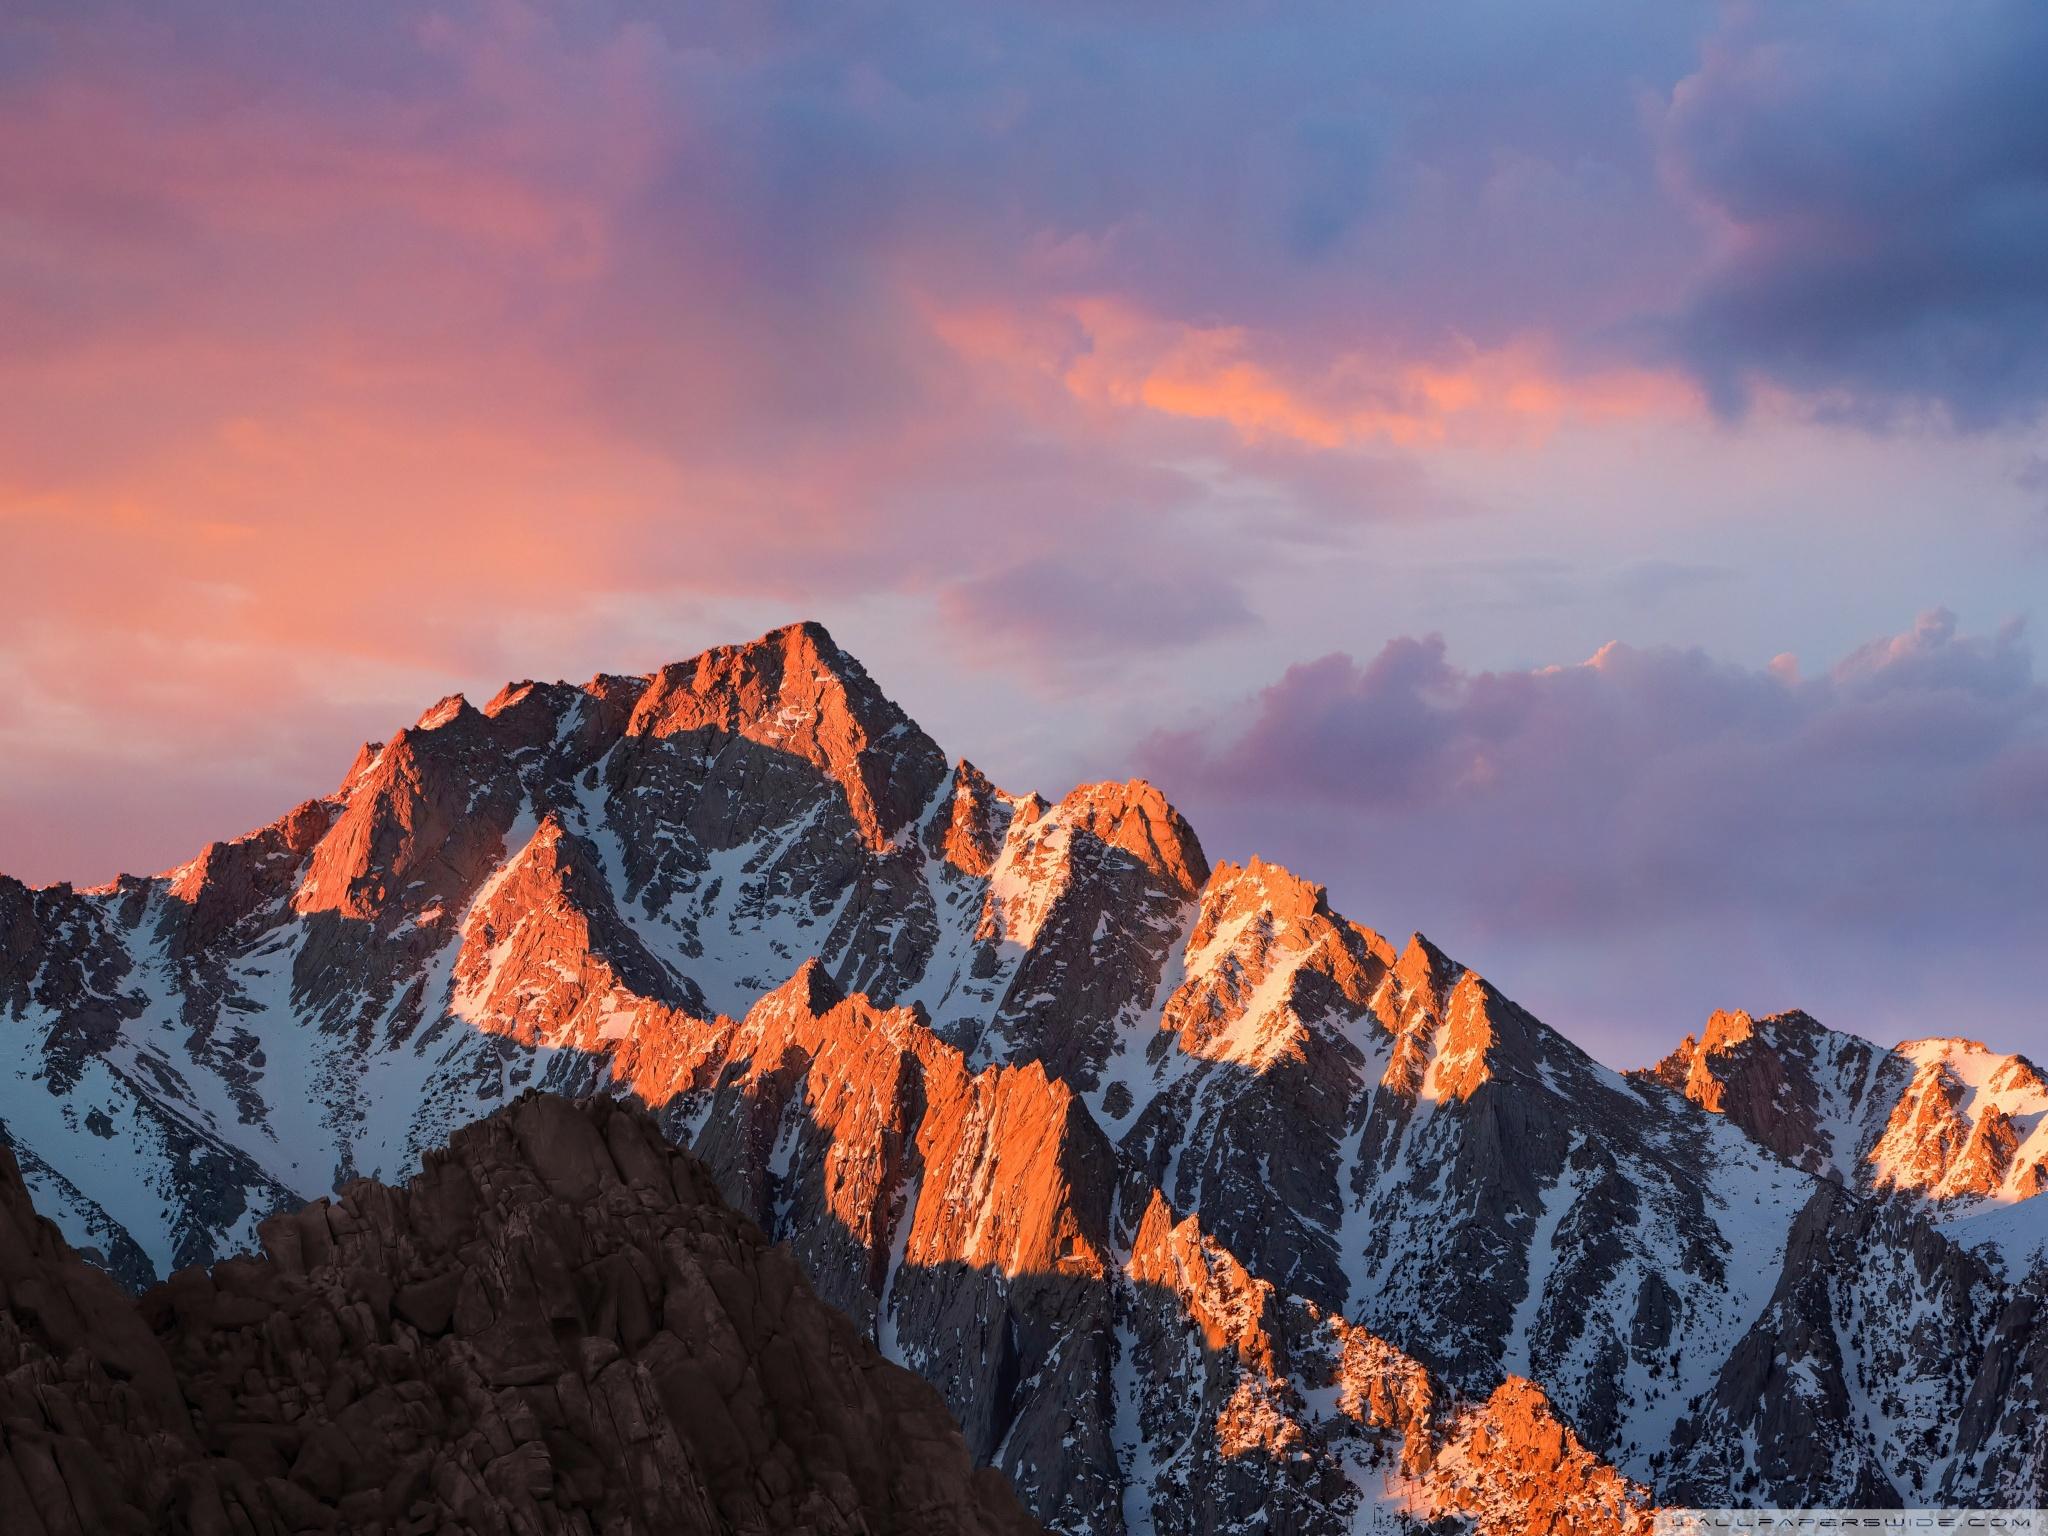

0,0,2048,1065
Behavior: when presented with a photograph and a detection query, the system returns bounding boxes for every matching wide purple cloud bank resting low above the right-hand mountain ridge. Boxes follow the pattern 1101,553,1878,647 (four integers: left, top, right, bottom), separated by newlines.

1141,612,2048,1057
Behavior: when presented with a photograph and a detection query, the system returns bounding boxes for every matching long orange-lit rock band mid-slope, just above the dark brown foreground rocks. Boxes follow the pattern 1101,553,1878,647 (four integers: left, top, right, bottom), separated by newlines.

455,909,1108,1302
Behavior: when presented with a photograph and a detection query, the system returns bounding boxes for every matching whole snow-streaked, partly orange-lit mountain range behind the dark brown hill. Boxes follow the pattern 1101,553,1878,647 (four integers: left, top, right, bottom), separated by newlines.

0,627,2048,1536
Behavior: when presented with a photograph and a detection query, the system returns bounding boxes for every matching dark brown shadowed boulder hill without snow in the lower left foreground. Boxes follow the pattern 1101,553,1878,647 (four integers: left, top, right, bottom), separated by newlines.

0,1096,1036,1536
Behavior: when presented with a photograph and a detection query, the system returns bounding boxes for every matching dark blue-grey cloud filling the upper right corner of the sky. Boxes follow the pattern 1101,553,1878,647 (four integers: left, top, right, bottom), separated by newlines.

1665,0,2048,426
